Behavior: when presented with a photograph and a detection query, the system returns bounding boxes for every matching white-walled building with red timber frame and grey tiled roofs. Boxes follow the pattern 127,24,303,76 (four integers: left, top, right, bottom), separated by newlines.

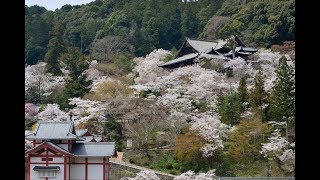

25,121,117,180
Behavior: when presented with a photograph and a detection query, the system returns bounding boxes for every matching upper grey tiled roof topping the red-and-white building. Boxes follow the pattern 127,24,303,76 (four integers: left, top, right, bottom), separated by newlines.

26,121,79,140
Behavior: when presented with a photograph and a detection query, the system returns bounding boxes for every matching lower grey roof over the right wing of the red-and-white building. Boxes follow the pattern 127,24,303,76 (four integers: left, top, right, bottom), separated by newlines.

71,142,116,157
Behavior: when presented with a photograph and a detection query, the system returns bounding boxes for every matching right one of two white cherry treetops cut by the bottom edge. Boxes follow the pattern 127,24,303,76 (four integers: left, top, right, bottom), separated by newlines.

174,170,216,180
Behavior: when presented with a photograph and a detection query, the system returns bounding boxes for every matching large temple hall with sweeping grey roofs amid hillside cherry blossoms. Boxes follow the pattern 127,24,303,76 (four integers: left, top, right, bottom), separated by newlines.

158,38,257,69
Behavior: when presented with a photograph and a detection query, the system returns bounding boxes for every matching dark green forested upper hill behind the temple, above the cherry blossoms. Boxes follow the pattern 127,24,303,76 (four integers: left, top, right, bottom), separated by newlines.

25,0,295,65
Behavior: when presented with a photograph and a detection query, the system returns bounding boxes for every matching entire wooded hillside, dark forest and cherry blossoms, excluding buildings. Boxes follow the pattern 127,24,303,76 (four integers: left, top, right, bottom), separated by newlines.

25,0,295,179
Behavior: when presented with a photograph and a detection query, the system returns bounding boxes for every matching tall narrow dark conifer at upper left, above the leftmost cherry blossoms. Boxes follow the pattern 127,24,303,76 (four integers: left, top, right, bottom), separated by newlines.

44,23,65,76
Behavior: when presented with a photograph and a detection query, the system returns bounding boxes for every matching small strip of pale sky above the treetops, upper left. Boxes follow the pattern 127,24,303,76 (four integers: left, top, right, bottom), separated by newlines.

25,0,94,11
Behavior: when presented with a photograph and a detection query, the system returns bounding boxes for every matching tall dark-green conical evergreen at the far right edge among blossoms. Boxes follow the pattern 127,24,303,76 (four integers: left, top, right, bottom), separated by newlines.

270,56,295,121
